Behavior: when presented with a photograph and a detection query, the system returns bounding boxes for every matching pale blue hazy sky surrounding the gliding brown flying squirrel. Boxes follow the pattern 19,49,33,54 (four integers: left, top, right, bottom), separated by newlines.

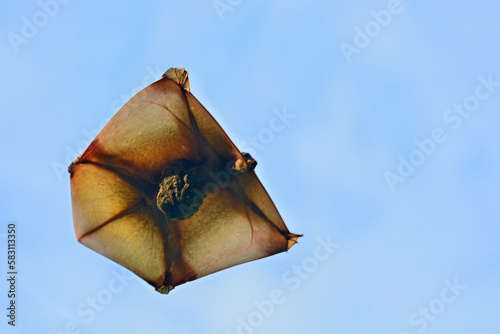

0,0,500,334
